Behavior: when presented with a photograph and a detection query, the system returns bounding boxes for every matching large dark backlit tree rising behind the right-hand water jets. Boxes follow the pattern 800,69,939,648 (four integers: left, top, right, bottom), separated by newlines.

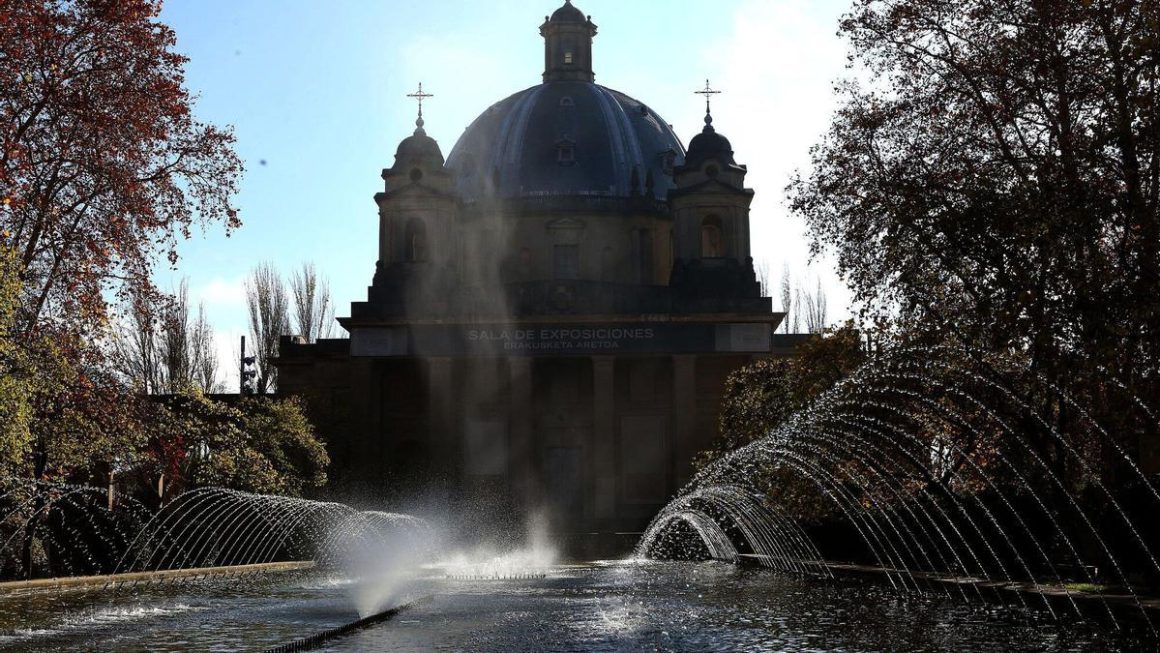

790,0,1160,489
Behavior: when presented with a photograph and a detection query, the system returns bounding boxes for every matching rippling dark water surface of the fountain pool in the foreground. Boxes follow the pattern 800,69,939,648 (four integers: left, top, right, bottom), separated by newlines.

0,561,1150,653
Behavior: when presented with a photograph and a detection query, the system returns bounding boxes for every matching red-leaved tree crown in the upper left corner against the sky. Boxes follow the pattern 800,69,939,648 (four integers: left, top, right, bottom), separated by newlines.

0,0,242,334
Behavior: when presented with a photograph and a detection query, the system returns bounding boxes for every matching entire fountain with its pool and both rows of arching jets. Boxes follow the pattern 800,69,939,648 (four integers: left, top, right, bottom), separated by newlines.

0,347,1160,652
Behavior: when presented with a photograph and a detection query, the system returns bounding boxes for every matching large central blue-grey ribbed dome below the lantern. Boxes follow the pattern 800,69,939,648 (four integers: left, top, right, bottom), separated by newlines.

447,81,684,202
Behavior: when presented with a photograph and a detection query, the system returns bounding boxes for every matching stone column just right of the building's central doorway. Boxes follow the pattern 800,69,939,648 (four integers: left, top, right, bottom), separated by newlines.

589,356,617,530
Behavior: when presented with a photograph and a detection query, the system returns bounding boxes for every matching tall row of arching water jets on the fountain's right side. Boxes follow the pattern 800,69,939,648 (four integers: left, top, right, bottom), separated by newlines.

637,347,1160,632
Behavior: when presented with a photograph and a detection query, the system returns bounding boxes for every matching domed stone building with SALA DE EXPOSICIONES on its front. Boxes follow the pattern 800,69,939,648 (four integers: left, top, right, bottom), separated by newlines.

277,1,783,545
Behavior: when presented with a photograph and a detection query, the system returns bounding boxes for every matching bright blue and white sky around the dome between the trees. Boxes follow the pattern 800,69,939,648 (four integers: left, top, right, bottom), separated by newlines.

158,0,849,390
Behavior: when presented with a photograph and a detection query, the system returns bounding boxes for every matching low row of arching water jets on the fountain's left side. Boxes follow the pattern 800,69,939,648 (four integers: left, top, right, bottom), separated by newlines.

0,480,433,580
